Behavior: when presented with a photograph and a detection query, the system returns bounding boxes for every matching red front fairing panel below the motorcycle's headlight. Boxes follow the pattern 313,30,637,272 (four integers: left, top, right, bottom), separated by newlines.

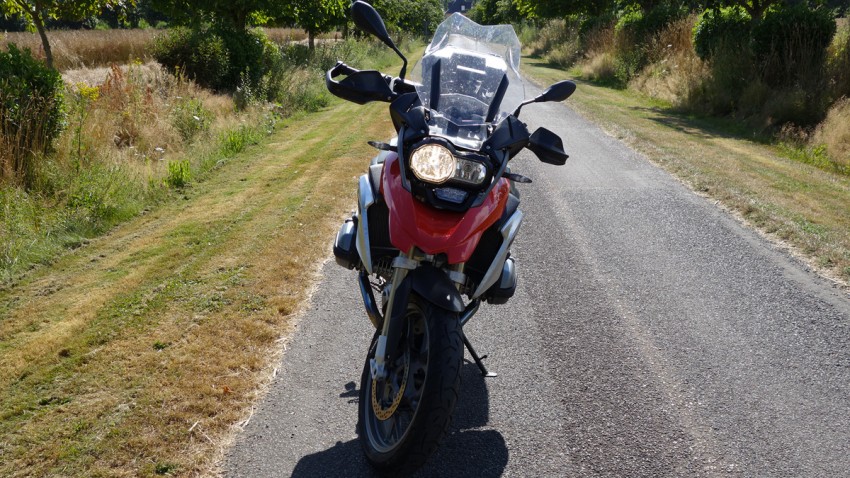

381,154,510,264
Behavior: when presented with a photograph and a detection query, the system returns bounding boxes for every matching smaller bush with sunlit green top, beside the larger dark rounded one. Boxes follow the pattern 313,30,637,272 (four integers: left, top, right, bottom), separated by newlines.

693,6,752,60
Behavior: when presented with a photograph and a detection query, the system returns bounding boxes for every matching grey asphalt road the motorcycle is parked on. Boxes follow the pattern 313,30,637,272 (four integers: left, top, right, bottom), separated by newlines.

225,88,850,477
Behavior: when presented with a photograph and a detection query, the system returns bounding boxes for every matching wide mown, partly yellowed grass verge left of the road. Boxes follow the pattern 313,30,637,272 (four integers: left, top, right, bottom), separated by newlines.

0,96,392,476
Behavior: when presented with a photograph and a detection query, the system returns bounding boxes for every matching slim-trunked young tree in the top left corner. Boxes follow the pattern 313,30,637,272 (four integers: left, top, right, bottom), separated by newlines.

0,0,127,69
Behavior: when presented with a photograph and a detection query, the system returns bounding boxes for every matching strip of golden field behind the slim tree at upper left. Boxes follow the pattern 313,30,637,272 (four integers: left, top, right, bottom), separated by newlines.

0,29,159,71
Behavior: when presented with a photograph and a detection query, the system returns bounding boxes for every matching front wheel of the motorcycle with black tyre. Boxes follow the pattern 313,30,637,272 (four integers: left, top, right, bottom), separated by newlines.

358,293,463,474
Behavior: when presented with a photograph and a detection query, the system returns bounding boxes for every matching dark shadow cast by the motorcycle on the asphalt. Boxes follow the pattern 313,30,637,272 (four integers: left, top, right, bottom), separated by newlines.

292,362,508,478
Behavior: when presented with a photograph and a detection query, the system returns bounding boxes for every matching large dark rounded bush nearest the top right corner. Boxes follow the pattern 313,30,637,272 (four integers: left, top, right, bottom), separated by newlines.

752,4,836,88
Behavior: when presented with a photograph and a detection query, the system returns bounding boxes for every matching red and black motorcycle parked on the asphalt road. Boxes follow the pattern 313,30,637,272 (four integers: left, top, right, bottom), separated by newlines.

325,1,576,474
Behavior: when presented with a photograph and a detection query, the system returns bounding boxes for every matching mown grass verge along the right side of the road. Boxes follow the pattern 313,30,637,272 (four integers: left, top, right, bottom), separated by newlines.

523,58,850,287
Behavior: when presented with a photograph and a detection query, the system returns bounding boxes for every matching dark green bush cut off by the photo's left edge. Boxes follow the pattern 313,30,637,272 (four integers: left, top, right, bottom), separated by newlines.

0,43,65,187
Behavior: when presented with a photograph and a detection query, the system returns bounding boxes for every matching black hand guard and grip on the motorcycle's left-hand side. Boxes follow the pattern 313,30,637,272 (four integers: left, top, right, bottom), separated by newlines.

325,61,416,105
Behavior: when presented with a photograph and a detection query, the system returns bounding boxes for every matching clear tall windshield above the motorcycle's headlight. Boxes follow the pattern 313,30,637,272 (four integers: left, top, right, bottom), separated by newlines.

413,13,525,149
